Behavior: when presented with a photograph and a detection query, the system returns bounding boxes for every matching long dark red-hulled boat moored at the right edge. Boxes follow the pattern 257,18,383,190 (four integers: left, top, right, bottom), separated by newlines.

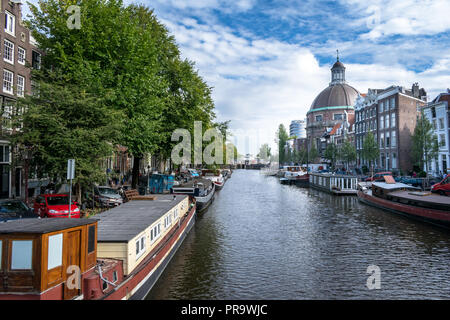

358,179,450,229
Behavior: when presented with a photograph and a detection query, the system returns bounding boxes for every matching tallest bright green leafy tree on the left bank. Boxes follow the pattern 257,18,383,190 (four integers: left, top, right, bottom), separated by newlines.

25,0,215,188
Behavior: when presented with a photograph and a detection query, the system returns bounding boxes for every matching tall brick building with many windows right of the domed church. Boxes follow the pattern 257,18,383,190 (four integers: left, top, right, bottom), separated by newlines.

355,83,426,174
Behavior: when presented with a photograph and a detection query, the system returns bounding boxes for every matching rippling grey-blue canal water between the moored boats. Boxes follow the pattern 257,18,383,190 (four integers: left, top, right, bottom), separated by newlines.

147,170,450,300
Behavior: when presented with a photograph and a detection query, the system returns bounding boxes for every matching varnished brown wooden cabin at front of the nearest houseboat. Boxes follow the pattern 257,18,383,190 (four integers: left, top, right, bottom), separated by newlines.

0,219,97,300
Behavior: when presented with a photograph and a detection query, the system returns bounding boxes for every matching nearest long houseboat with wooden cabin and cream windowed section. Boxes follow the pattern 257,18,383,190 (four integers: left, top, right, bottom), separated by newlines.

0,195,196,300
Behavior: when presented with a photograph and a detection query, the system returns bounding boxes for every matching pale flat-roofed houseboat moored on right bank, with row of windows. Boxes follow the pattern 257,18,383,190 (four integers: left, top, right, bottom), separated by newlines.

309,173,358,195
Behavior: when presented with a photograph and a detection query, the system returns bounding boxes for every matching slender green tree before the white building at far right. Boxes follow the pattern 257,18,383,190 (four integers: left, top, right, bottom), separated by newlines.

411,110,439,174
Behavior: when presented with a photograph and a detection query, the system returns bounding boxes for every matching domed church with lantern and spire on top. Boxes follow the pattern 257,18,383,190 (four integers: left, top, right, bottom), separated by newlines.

306,52,359,154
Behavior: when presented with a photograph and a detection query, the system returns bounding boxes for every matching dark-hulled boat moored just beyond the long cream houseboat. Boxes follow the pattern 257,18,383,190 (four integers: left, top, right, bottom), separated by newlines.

171,178,216,213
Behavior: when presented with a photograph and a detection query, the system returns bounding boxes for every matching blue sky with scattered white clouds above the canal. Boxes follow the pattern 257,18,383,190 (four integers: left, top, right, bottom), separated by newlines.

25,0,450,154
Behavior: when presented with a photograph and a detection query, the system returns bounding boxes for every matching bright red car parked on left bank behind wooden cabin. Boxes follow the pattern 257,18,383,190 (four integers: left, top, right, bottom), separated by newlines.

33,194,80,218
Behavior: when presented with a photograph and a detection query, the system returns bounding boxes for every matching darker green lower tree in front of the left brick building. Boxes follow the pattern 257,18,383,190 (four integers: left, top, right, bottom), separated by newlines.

11,72,122,201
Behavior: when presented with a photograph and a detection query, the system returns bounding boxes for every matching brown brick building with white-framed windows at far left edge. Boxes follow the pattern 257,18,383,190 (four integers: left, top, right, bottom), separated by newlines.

0,0,41,198
